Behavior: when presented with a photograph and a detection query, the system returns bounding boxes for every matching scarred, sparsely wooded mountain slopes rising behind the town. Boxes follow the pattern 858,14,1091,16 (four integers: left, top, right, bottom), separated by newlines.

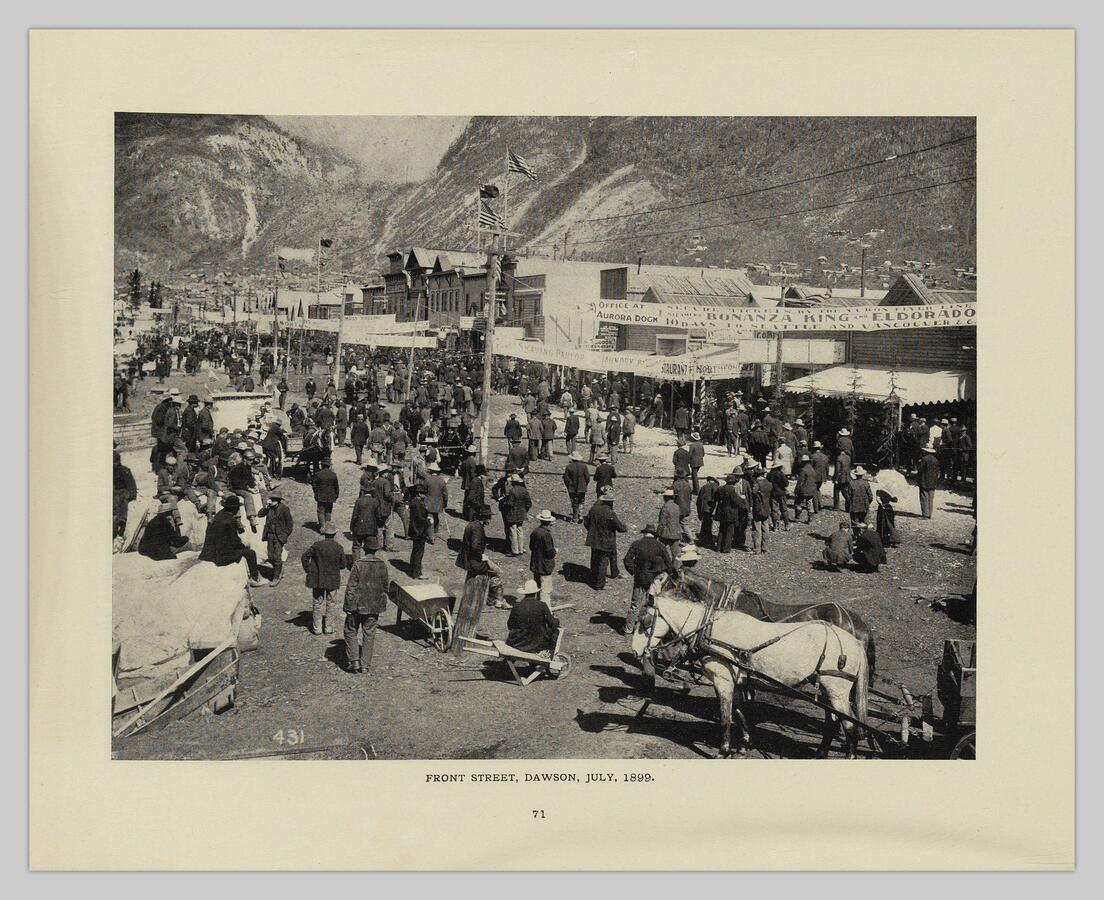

116,115,975,275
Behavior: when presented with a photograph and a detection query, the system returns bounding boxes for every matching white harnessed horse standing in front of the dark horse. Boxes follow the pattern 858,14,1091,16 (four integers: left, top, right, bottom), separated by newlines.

633,595,868,759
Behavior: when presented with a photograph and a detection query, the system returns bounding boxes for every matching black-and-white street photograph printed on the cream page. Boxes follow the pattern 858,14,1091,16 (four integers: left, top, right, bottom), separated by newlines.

109,109,975,759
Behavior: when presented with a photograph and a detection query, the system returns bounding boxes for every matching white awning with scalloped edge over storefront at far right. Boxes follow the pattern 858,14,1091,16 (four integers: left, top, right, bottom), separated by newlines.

785,366,975,406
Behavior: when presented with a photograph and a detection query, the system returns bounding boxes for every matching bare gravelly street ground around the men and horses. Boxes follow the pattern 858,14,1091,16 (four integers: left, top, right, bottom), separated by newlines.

116,364,976,759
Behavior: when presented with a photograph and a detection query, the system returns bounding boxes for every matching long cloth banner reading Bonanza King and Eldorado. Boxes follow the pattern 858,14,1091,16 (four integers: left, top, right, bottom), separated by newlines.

594,300,977,332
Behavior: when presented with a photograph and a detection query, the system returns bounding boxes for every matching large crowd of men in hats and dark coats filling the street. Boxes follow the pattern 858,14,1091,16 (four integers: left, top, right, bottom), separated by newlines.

113,331,973,673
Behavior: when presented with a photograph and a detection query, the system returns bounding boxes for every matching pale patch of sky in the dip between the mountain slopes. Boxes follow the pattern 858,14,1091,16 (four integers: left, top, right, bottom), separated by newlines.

269,116,468,181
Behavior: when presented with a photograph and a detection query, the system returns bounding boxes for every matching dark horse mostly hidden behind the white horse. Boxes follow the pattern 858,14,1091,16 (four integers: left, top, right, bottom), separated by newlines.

657,569,875,682
